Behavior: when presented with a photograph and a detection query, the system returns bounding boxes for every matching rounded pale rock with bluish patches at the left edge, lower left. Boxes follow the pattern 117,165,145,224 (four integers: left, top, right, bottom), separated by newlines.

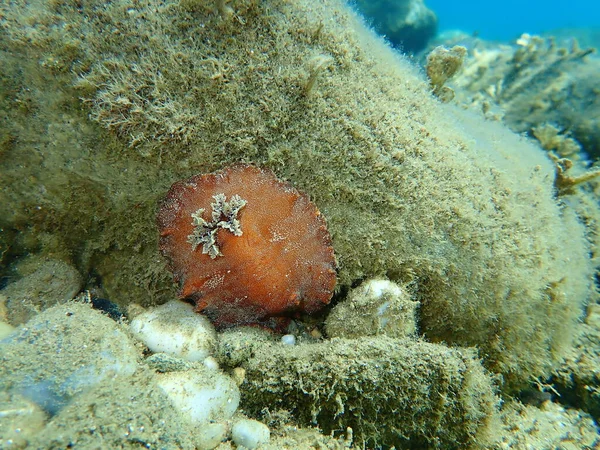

0,302,138,414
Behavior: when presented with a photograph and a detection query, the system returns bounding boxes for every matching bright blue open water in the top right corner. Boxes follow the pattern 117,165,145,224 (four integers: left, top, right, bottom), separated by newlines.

425,0,600,41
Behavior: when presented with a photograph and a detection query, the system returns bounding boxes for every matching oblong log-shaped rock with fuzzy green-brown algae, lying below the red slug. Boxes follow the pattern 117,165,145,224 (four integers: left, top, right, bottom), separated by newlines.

240,337,497,449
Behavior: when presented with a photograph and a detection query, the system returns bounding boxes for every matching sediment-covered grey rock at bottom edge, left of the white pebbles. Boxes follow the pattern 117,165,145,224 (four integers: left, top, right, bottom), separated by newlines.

29,370,202,450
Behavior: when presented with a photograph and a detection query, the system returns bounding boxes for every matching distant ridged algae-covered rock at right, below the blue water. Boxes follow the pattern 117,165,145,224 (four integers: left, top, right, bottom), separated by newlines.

451,34,600,160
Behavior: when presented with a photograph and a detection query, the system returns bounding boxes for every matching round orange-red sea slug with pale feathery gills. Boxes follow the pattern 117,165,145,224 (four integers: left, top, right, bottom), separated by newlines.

158,164,336,328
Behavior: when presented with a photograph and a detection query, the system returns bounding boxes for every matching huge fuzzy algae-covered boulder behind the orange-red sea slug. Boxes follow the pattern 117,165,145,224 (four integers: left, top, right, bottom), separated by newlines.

0,0,591,390
